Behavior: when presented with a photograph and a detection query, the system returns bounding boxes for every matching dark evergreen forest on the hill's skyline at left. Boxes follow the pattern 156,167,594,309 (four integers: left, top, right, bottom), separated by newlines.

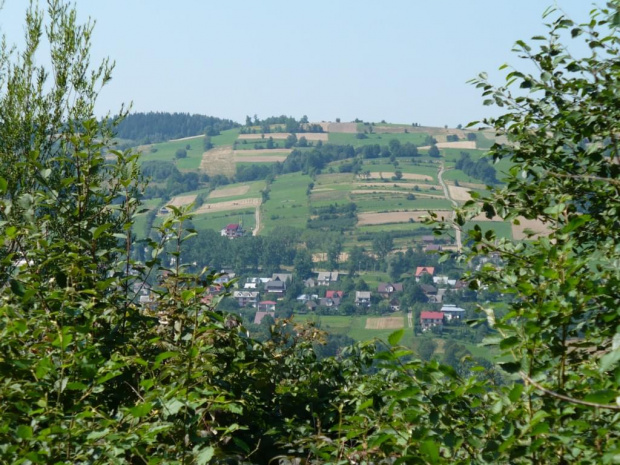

116,112,239,144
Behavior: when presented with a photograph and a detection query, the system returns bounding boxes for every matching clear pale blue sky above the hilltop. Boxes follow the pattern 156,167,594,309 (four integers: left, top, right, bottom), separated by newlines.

0,0,592,127
